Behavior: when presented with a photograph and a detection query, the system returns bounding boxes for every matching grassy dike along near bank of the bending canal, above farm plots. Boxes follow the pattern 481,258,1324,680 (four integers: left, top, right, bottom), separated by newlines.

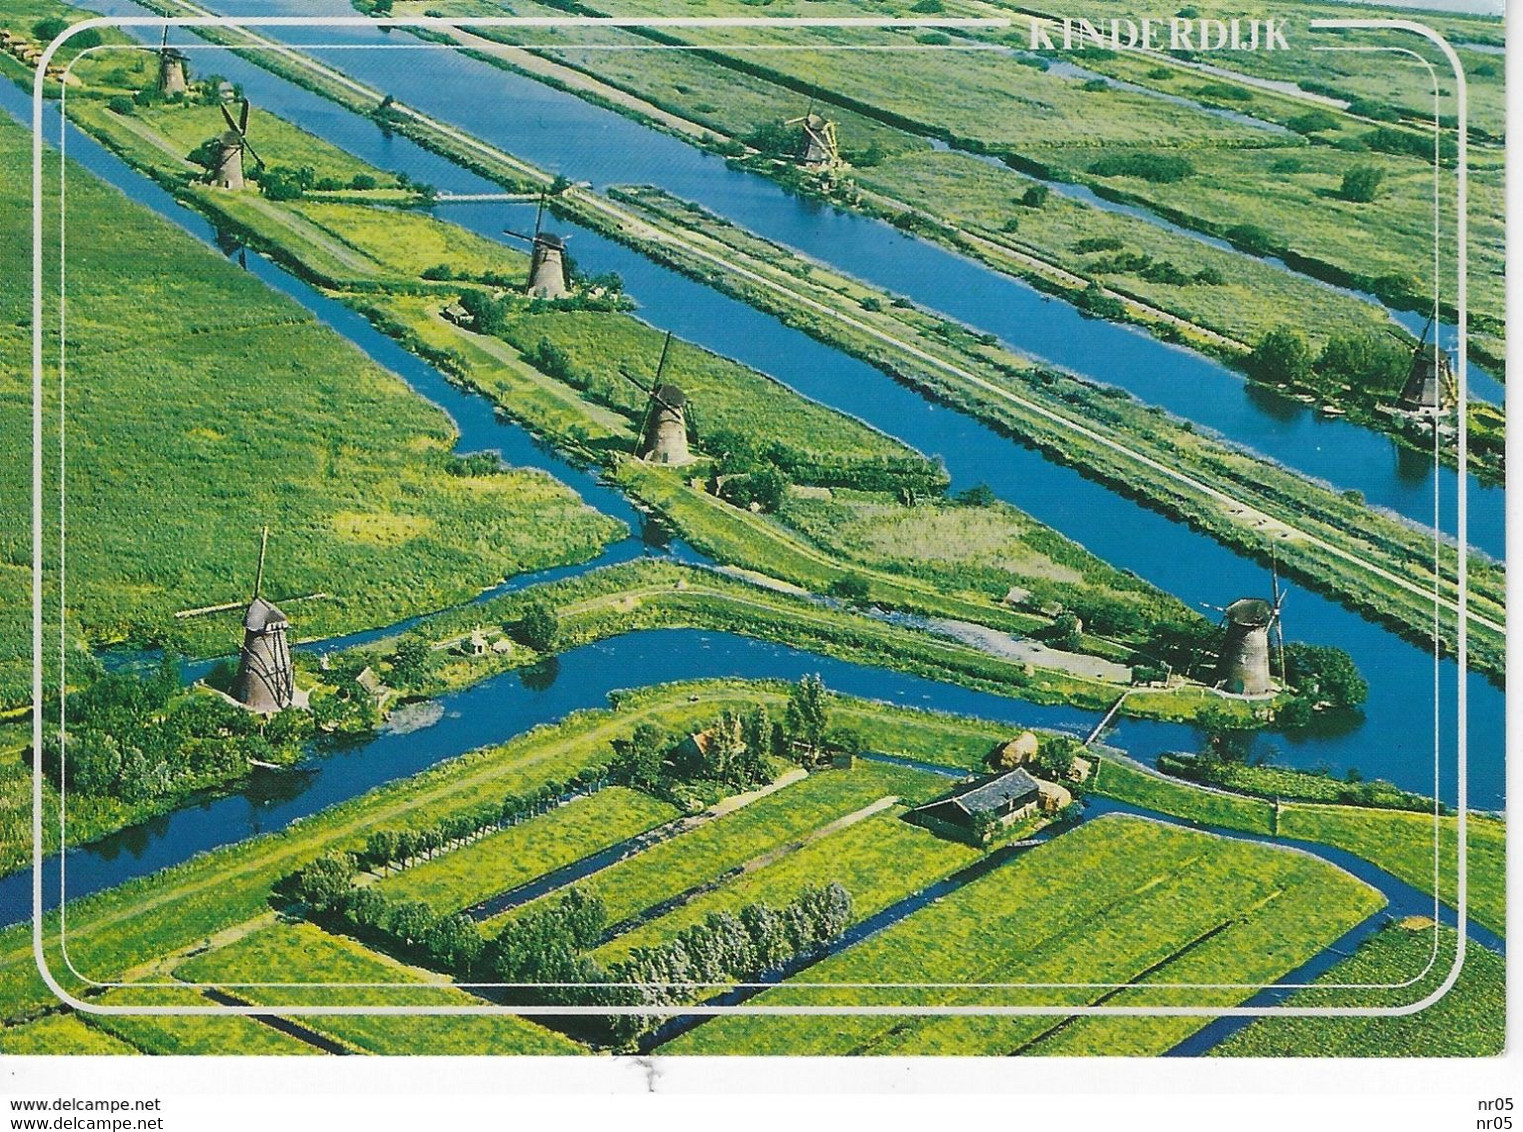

0,680,1502,1024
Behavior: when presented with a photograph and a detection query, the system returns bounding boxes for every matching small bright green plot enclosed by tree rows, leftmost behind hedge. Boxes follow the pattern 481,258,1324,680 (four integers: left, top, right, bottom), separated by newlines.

381,786,678,913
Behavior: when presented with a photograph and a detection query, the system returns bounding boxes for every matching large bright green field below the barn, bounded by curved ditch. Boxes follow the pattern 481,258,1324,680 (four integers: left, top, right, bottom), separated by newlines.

661,818,1381,1056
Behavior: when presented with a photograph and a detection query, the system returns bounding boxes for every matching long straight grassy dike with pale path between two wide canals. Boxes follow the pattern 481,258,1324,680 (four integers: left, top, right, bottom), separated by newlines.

44,13,1502,680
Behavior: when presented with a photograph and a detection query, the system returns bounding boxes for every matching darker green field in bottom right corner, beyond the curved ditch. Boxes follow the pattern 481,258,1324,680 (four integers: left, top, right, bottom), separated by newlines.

1211,920,1506,1057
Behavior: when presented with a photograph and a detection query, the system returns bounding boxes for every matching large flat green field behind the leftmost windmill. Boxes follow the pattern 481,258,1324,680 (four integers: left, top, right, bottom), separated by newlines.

0,108,617,698
